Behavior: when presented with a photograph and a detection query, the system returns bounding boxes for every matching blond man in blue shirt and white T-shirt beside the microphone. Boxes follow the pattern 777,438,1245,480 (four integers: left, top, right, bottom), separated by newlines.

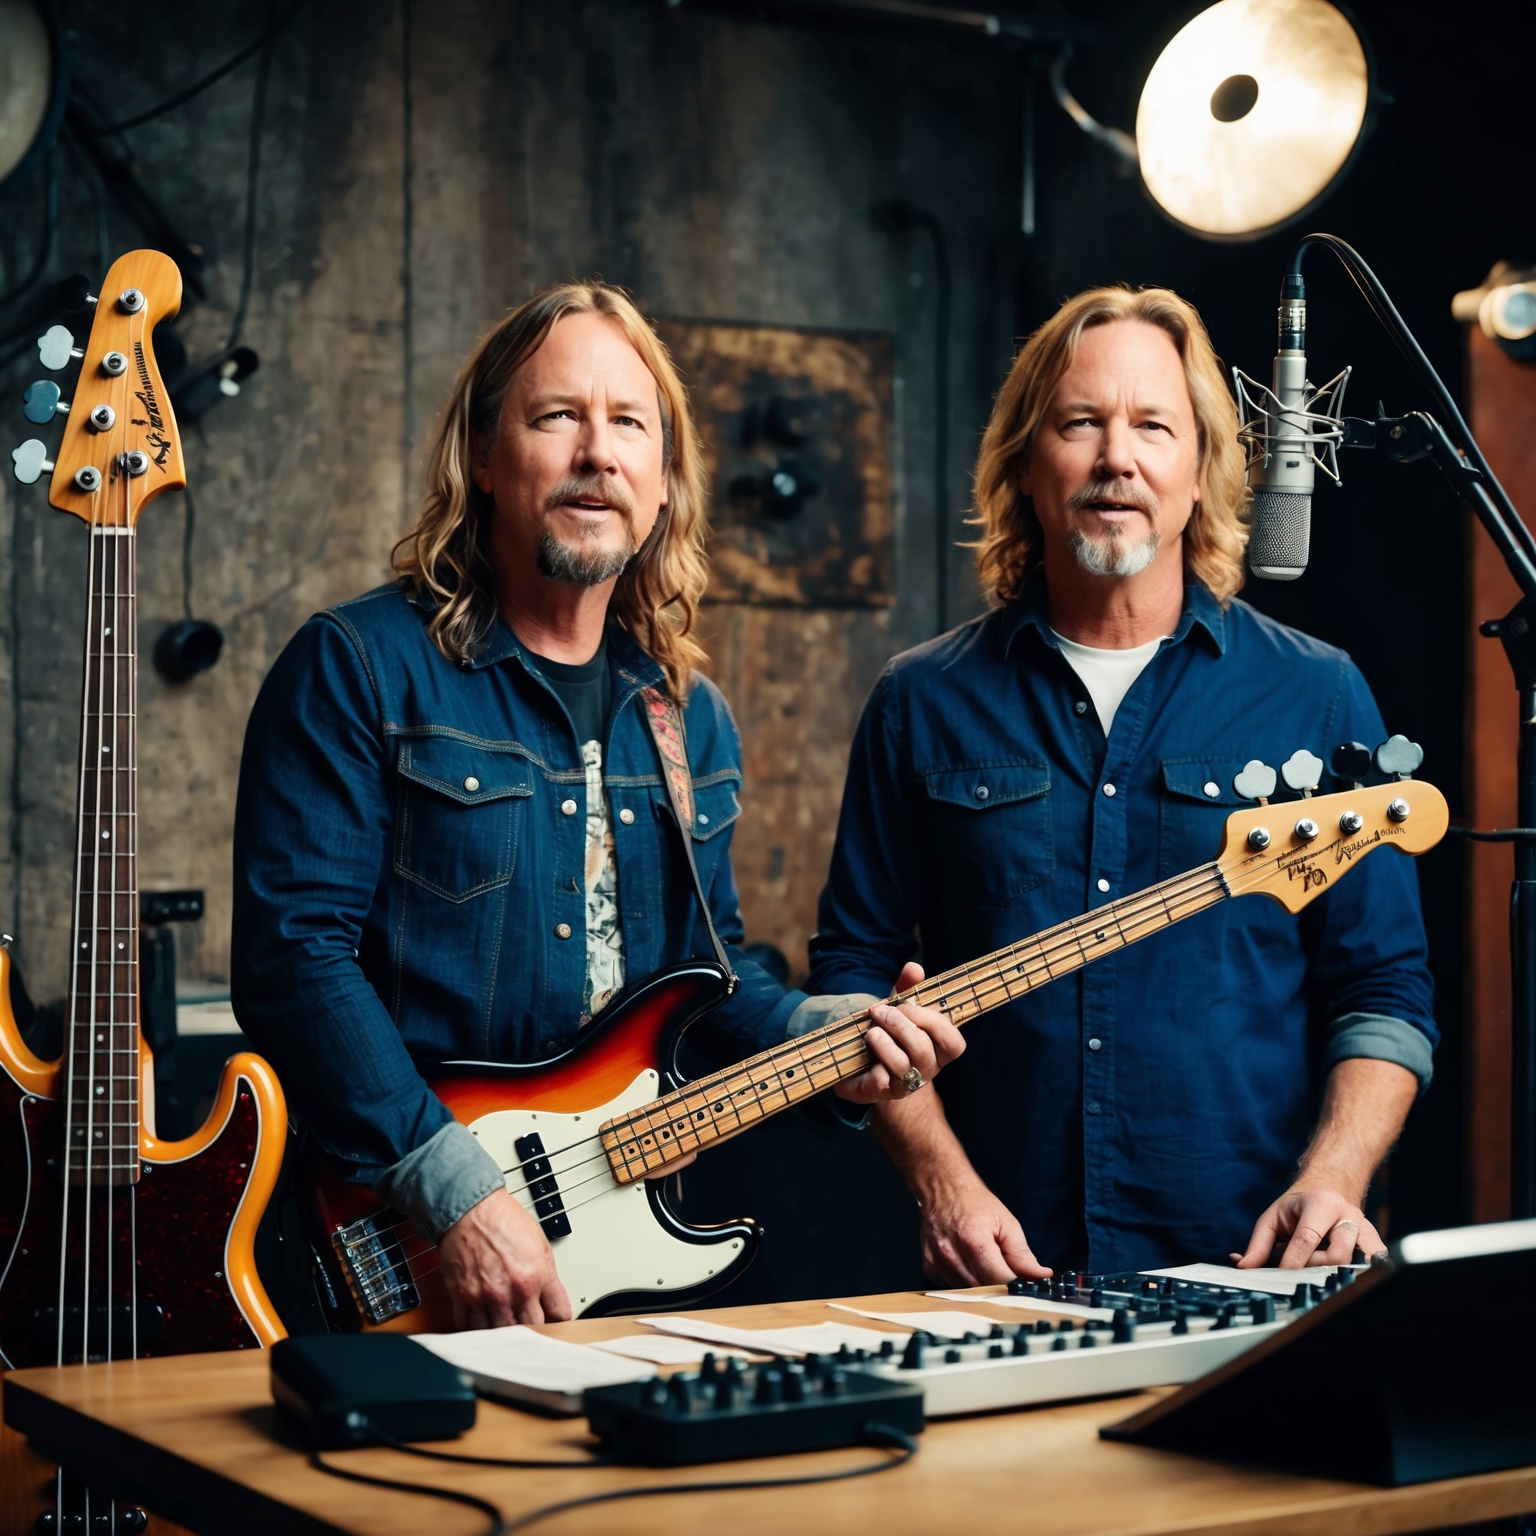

811,287,1438,1284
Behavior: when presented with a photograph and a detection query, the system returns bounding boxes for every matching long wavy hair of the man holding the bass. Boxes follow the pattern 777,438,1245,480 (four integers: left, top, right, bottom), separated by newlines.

393,283,708,702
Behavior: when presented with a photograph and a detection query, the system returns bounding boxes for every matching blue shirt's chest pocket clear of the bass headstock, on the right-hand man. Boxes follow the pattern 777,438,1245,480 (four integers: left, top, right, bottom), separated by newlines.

923,759,1055,909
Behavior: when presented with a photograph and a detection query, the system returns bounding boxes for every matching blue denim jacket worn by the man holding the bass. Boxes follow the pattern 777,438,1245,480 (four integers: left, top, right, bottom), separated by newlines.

232,587,805,1204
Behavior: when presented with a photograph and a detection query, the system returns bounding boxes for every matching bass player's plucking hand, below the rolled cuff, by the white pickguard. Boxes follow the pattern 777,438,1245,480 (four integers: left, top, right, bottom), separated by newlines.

438,1189,571,1329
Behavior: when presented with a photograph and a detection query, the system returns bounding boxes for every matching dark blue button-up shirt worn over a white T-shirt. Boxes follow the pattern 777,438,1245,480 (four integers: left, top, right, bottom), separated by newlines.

809,573,1438,1270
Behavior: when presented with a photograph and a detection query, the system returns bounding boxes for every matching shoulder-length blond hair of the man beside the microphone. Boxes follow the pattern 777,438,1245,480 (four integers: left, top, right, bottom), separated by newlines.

969,284,1249,605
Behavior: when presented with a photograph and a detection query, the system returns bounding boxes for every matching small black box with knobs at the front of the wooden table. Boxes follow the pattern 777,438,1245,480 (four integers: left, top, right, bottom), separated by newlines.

585,1356,923,1467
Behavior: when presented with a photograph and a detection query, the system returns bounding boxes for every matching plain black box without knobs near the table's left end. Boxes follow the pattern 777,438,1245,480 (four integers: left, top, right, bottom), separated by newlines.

272,1333,475,1450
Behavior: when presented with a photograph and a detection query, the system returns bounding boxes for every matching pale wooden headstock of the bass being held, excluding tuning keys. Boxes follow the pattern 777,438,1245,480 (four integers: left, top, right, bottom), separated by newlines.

1217,780,1450,912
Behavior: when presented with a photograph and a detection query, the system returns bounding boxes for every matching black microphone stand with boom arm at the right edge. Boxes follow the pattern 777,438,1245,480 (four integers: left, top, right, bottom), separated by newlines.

1290,233,1536,1220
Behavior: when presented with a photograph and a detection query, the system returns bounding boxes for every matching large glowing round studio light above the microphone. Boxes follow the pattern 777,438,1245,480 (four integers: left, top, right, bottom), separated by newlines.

1137,0,1370,240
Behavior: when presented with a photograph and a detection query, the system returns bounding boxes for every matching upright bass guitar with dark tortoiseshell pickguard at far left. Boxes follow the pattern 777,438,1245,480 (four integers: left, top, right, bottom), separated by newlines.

0,250,287,1369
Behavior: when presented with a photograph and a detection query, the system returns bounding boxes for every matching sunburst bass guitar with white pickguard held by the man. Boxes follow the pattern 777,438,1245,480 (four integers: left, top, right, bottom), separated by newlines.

309,768,1448,1332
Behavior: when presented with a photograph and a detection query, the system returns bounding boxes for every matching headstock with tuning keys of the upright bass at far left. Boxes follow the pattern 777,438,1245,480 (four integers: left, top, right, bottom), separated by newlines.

11,250,186,527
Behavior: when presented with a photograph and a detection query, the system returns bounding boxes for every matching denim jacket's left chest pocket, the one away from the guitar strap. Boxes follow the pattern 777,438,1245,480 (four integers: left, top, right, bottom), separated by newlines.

395,736,533,902
